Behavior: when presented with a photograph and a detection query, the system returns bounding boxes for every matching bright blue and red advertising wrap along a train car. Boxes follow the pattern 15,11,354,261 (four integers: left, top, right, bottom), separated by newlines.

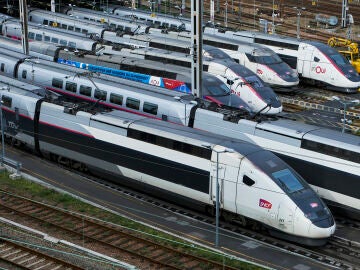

58,58,191,93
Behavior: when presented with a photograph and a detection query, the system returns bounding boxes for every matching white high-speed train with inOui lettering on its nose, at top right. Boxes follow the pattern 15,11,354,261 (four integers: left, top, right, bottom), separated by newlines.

204,28,360,93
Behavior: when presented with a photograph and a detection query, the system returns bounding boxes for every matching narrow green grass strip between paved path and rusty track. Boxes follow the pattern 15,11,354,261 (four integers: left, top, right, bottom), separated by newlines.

0,173,263,270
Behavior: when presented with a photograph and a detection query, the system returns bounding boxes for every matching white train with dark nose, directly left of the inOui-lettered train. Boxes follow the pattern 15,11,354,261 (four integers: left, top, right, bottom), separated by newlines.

109,31,299,89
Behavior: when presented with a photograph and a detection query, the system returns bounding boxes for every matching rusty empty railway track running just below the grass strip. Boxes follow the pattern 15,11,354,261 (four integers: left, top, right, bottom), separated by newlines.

0,191,242,270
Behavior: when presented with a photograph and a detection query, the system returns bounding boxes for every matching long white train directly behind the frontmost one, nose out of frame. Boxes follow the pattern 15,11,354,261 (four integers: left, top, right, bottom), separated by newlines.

0,45,360,222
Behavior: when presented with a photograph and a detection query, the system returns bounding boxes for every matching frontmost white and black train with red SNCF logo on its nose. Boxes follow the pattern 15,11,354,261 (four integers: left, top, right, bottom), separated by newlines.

0,91,336,246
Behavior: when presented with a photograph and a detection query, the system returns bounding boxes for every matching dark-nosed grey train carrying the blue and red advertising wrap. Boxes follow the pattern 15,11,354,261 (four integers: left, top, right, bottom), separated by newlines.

0,38,253,113
